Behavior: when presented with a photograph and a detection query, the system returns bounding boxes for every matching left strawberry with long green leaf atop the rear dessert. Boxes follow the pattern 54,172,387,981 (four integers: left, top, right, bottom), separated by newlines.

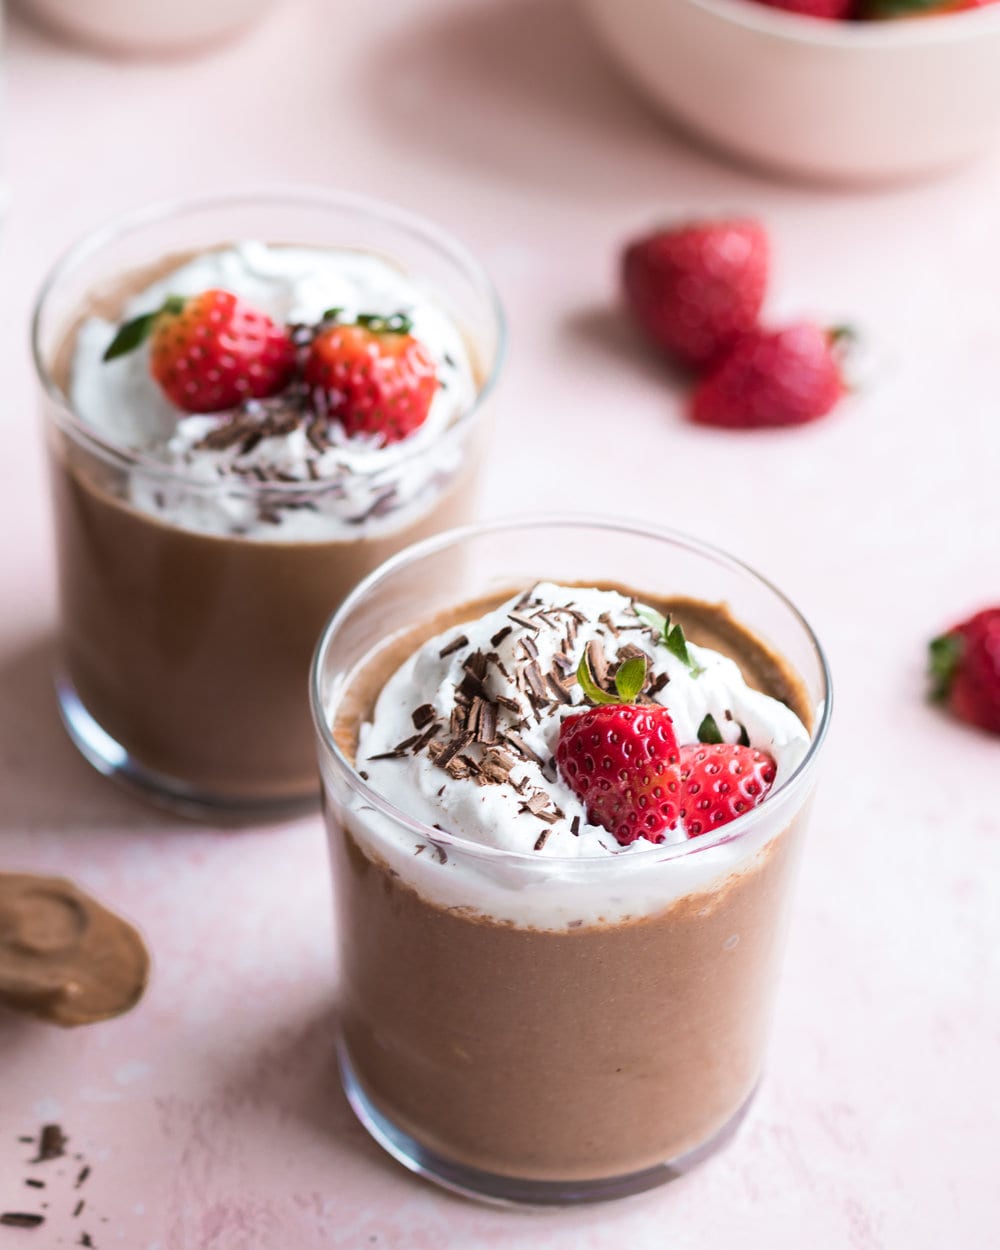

104,290,296,413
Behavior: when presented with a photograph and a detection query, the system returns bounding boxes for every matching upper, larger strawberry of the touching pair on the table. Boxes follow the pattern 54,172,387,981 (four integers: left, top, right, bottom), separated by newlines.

623,220,770,368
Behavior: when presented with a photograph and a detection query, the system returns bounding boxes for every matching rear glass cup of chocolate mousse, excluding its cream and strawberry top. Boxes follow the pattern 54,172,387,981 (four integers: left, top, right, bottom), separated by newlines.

34,182,503,816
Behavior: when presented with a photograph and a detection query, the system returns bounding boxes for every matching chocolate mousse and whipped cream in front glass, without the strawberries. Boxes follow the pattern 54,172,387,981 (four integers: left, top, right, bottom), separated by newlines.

328,586,811,1201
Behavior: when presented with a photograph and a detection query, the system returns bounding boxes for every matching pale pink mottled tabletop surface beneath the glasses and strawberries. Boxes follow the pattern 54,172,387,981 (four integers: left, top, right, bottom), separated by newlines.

0,0,1000,1250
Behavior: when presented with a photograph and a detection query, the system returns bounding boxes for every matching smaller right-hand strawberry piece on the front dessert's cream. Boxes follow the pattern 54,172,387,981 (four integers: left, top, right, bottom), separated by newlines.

678,743,775,838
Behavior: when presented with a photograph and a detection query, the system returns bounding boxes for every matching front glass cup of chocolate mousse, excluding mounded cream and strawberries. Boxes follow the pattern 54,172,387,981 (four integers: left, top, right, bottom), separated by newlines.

310,518,830,1204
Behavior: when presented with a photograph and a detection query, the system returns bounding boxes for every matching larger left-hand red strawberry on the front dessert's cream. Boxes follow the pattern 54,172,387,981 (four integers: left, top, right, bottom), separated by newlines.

555,704,678,846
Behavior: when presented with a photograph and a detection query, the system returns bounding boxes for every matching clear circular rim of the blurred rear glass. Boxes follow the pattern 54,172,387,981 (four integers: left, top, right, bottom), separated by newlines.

30,184,508,495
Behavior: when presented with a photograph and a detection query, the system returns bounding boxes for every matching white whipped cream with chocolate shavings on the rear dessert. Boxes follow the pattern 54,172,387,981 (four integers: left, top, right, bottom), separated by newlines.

70,243,478,541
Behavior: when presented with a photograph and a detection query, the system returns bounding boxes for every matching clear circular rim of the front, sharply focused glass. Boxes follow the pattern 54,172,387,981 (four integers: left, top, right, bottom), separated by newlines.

309,513,833,873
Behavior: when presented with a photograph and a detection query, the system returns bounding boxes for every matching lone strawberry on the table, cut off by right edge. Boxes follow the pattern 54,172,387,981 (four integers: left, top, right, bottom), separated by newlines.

930,608,1000,734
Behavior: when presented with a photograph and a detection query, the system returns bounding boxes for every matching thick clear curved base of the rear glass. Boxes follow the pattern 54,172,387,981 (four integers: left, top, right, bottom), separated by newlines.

55,671,320,824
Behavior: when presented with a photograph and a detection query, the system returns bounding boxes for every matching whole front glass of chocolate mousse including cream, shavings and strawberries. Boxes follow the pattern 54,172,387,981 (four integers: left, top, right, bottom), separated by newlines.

311,518,830,1204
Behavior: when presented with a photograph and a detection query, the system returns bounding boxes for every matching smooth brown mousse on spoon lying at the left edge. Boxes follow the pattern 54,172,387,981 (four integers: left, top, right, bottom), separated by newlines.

0,873,149,1028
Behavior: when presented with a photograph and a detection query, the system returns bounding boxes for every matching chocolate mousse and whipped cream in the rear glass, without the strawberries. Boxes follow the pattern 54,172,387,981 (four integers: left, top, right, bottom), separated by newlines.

40,230,489,809
